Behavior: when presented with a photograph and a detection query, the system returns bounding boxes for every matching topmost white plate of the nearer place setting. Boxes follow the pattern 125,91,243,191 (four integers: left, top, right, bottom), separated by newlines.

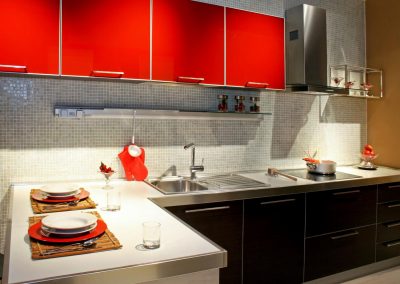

42,212,97,230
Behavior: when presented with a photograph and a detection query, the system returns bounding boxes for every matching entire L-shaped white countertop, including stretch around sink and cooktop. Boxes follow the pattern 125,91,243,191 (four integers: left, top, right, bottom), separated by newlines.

3,166,400,284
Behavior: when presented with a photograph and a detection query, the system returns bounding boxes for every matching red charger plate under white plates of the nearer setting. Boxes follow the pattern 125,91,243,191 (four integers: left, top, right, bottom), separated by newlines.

28,219,107,243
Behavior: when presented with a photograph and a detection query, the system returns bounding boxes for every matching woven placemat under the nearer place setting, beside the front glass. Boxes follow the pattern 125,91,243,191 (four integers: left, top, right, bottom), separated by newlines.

29,212,122,259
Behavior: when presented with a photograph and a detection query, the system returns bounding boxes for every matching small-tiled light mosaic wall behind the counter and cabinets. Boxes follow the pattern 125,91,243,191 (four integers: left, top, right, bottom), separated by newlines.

0,0,366,251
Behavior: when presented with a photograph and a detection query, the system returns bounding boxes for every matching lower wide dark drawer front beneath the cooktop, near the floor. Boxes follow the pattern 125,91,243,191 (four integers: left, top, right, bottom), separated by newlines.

304,225,375,281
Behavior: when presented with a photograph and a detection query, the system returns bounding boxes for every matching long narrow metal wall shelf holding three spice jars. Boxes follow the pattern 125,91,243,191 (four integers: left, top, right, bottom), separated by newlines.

54,106,271,121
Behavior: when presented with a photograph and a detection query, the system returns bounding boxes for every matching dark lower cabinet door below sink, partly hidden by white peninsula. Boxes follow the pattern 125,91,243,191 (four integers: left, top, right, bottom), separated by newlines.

166,201,243,284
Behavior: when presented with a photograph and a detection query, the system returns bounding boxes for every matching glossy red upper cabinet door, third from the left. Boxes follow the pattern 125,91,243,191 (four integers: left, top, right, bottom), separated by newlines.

153,0,224,85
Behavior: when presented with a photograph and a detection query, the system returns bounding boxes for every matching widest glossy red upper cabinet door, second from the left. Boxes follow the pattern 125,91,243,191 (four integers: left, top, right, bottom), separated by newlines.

62,0,150,79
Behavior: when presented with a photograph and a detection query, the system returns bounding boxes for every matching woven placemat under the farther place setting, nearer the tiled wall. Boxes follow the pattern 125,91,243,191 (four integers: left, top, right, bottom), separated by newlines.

31,189,96,214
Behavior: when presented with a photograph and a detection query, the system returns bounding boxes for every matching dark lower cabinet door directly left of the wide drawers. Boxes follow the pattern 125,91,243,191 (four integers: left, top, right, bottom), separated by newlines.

243,194,305,284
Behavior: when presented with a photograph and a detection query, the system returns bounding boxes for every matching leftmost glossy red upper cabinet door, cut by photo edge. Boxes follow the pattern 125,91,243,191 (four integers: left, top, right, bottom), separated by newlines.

0,0,59,74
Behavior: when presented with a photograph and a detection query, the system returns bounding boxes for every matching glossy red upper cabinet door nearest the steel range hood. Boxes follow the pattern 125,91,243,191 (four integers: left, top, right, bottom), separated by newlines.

226,8,285,89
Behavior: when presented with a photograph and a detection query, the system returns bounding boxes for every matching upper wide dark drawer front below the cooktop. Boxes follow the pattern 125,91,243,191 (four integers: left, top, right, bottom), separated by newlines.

306,186,376,236
